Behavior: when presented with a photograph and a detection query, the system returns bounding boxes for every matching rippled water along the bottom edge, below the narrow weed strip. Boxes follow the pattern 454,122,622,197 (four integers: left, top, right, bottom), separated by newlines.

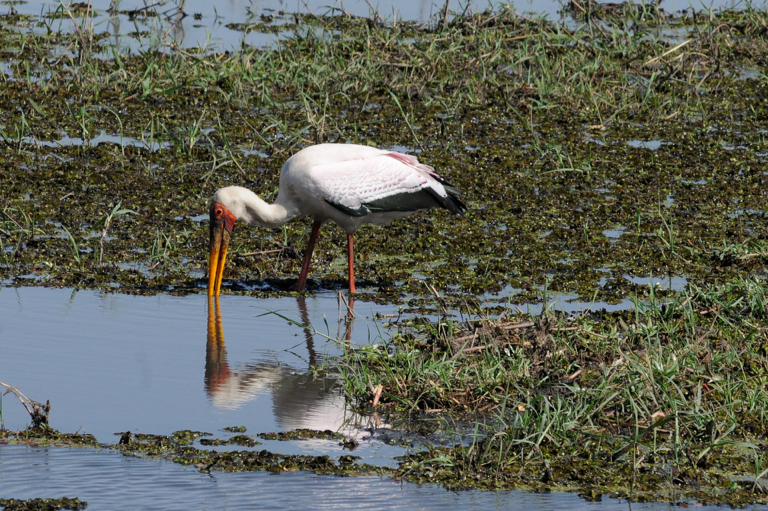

0,446,740,511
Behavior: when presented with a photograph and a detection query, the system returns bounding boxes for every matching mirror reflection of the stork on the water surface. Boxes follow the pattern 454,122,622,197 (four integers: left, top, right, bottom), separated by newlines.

205,296,354,431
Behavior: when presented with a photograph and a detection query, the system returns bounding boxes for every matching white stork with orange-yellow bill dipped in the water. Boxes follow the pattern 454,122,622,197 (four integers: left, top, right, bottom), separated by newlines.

208,144,466,295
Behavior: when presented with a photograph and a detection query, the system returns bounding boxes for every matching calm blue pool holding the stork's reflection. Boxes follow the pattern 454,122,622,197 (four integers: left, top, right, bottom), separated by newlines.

0,288,392,442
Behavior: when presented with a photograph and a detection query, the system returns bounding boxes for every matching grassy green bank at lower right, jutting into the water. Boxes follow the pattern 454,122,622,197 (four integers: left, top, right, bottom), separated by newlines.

339,279,768,505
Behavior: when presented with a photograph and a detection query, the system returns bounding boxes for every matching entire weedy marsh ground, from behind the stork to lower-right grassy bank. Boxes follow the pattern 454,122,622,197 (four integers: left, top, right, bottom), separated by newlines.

0,3,768,506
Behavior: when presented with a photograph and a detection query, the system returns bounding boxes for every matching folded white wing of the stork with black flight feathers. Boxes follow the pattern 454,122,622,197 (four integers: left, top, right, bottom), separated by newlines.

310,152,452,216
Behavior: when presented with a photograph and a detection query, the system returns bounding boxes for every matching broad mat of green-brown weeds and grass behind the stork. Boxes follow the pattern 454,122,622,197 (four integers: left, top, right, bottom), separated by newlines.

0,4,768,309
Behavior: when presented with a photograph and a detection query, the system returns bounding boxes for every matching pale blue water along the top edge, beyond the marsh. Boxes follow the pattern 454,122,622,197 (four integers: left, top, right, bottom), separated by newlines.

13,0,767,50
